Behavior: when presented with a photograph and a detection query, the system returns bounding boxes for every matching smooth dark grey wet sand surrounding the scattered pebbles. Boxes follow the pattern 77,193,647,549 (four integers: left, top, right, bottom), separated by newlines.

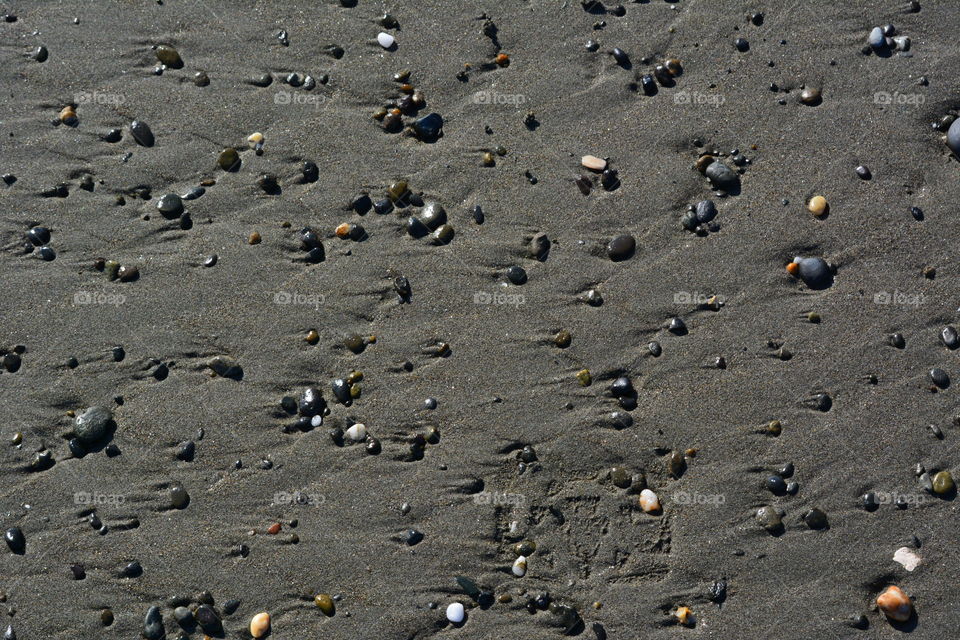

0,0,960,640
